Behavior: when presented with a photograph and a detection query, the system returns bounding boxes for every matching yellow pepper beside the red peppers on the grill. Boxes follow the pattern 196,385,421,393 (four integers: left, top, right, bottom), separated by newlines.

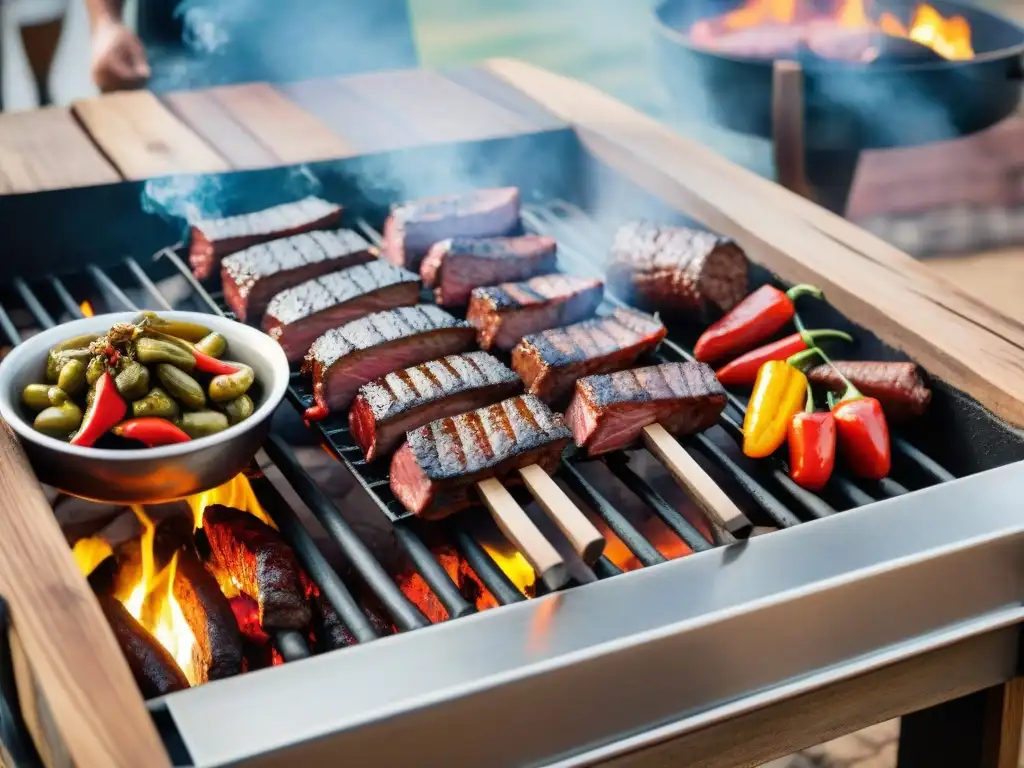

743,360,807,459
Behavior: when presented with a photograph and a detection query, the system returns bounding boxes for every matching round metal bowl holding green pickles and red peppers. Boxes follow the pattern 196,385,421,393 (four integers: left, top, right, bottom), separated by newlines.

0,311,289,504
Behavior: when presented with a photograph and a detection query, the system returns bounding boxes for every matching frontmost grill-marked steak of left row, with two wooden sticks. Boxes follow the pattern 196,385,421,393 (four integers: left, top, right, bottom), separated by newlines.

391,394,572,519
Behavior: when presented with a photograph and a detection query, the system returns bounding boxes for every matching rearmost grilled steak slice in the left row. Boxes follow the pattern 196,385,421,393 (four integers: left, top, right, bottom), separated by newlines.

188,198,341,280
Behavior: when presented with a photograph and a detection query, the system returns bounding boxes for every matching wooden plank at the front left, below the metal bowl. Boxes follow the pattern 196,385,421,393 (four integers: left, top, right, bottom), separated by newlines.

0,429,170,768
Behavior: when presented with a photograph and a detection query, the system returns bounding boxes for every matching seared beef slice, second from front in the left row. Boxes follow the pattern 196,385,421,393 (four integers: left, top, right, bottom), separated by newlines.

348,352,522,461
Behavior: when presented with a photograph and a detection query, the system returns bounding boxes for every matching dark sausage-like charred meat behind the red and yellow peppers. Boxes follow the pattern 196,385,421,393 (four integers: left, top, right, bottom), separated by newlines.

807,360,932,422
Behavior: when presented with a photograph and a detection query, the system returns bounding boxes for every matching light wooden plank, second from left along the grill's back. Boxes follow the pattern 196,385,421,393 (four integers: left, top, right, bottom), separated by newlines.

73,91,230,179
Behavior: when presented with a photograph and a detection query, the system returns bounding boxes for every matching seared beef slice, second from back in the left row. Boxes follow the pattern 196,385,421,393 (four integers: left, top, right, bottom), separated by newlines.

220,229,377,323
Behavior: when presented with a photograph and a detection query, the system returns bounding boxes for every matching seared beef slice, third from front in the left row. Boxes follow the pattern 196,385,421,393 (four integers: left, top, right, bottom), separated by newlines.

302,304,473,421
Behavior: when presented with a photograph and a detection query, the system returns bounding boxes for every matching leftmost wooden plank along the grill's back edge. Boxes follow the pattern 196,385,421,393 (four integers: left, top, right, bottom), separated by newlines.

0,106,121,194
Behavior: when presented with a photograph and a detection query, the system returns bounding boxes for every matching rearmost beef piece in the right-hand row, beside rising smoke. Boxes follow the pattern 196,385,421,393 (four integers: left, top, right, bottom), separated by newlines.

381,186,519,270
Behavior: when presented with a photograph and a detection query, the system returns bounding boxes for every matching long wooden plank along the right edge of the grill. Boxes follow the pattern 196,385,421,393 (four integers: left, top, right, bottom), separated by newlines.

486,59,1024,426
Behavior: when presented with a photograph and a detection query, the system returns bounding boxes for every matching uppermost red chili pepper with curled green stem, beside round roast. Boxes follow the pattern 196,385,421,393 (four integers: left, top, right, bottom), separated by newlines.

693,285,821,362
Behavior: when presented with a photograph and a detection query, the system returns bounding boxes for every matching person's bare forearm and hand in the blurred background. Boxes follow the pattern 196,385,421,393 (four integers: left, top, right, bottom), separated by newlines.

85,0,150,92
